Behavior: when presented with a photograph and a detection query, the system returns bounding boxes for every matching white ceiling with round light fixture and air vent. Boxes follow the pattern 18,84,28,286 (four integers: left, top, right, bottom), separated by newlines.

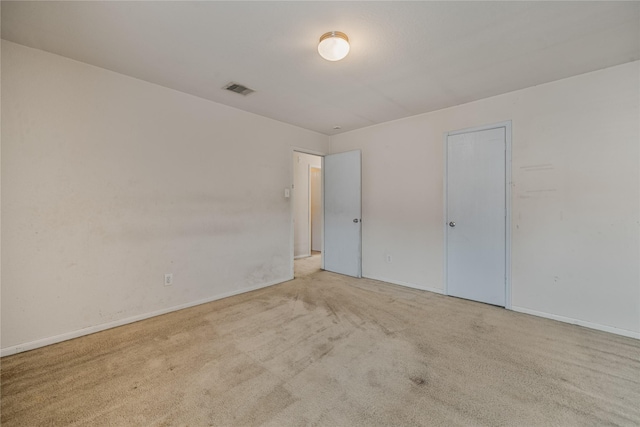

1,1,640,135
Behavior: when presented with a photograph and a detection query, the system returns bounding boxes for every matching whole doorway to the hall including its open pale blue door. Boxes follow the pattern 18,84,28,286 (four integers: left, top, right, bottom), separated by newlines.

285,148,362,278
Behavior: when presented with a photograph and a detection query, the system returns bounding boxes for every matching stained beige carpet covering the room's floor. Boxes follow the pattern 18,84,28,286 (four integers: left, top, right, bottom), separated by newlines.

1,257,640,426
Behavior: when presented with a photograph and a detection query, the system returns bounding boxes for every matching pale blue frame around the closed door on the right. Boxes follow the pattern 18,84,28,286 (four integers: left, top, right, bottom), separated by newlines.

442,120,512,310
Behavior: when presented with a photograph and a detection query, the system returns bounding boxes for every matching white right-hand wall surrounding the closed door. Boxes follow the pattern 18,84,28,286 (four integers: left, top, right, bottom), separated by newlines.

332,62,640,338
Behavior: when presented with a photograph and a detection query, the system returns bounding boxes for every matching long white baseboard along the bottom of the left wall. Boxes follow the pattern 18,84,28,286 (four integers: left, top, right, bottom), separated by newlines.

0,278,292,357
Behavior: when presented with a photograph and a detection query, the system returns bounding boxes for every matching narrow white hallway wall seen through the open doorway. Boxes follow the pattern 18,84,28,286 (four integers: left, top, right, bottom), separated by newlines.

293,152,322,258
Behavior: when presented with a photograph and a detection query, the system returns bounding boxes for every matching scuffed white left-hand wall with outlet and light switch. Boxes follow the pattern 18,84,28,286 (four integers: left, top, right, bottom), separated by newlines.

1,41,329,355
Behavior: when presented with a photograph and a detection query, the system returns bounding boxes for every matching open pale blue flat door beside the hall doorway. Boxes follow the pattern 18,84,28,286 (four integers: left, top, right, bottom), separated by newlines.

323,150,362,277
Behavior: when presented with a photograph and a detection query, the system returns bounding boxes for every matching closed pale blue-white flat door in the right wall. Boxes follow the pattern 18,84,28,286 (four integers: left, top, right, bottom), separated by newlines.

445,127,507,307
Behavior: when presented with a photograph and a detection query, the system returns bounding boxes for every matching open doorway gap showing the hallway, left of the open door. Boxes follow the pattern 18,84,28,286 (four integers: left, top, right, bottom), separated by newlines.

293,151,323,259
